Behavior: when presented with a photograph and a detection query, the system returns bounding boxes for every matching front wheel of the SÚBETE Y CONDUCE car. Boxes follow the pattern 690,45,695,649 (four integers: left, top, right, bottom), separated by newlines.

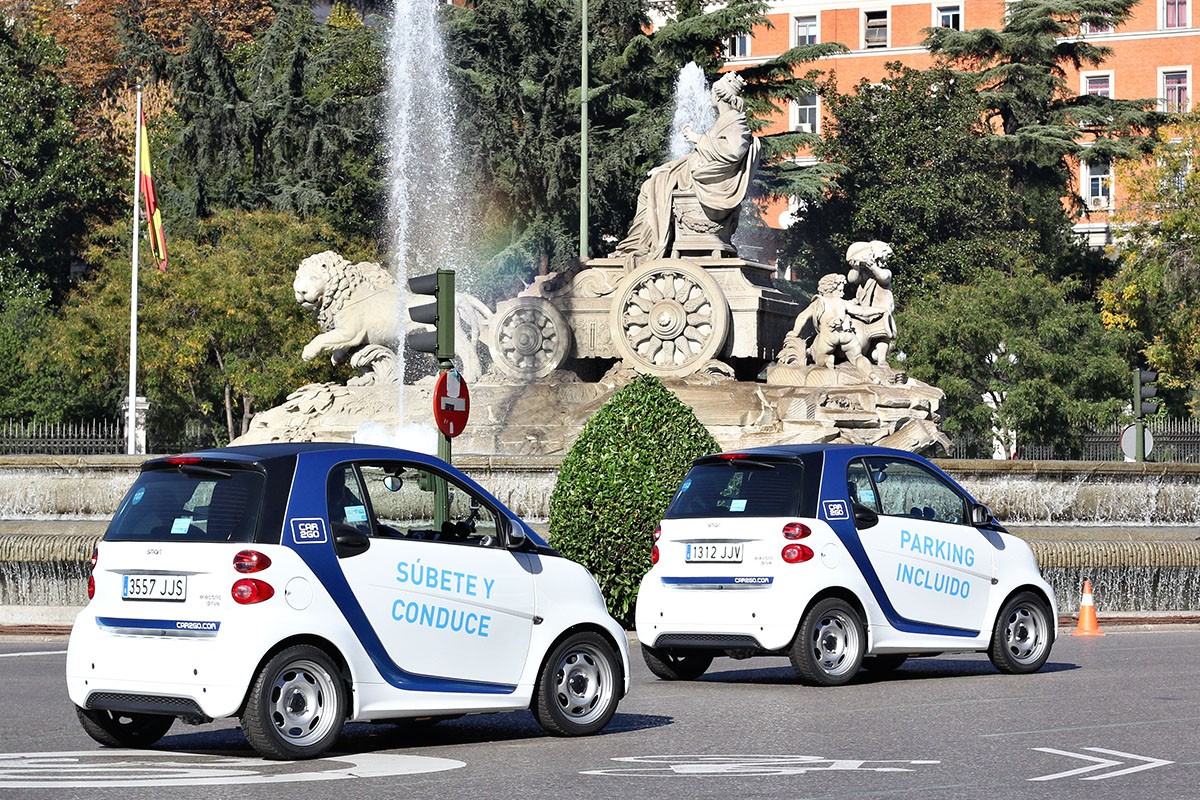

534,633,624,736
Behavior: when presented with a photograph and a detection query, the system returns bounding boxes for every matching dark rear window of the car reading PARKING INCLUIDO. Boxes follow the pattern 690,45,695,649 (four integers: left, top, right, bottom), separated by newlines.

666,459,804,519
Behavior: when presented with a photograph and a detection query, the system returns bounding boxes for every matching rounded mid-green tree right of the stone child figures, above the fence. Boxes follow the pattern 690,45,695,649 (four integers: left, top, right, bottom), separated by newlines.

896,270,1130,457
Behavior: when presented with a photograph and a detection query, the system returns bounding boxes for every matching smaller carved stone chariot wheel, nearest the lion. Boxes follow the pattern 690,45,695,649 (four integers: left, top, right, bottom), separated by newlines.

491,297,571,380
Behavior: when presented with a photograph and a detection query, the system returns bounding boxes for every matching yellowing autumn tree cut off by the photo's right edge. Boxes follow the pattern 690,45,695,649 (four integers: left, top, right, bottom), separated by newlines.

1100,113,1200,411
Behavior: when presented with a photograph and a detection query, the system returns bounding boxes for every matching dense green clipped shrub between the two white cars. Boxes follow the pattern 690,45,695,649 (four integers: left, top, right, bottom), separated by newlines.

550,375,720,627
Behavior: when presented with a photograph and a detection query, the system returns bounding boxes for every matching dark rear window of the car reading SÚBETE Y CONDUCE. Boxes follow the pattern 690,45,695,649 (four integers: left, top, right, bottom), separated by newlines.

104,467,265,542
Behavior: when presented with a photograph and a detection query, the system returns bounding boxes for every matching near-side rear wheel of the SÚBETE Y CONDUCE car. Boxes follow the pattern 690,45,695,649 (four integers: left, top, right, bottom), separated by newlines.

241,644,347,760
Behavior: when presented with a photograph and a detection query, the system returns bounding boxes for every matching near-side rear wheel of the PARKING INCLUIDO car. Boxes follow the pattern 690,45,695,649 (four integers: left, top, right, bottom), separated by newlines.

790,597,865,686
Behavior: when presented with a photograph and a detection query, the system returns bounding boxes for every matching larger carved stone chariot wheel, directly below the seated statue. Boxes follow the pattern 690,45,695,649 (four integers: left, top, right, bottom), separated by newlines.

611,259,730,378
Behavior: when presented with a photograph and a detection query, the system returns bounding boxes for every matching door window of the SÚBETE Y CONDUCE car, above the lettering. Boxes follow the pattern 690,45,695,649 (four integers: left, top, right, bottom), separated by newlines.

359,462,500,547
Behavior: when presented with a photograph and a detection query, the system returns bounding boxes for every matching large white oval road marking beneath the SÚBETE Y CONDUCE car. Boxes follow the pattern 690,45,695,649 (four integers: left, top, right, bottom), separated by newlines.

0,750,466,789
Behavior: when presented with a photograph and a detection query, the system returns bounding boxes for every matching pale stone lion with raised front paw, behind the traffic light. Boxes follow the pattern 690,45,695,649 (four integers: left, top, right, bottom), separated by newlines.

292,251,491,386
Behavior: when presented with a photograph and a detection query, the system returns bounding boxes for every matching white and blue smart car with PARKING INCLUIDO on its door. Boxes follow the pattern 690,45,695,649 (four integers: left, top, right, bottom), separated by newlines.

636,445,1057,686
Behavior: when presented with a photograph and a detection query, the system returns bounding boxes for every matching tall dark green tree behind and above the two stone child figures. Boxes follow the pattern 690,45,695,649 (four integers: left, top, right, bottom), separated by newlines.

790,64,1033,299
